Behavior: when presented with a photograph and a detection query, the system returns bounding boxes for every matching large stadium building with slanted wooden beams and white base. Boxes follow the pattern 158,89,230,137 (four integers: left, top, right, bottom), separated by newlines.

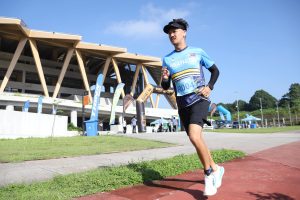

0,18,177,137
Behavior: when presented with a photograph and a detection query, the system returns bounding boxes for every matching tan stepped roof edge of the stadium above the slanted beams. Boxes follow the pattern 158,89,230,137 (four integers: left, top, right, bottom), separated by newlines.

0,17,176,107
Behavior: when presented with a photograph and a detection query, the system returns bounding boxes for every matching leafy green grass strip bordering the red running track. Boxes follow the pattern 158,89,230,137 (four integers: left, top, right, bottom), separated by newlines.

0,150,244,200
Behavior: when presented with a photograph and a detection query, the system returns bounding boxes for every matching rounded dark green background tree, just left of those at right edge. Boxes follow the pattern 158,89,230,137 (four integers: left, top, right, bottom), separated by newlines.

249,90,277,111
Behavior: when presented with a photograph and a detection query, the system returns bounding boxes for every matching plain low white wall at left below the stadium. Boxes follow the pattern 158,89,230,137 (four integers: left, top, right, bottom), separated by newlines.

0,110,68,138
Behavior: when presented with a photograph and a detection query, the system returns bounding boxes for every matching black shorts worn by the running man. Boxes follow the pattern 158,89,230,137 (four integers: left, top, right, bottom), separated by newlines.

178,99,210,134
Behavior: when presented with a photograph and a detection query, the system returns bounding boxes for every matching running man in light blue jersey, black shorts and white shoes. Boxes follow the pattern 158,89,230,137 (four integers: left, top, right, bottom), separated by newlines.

161,19,224,196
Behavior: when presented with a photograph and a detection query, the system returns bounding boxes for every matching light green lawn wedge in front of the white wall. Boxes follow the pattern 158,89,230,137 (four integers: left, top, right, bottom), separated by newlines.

0,136,175,162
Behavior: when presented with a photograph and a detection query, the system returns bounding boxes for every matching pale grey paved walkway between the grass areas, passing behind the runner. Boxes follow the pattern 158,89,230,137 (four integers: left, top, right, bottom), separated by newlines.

0,131,300,186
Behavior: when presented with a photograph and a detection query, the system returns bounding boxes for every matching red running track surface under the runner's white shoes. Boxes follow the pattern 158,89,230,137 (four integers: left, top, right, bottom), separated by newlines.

79,141,300,200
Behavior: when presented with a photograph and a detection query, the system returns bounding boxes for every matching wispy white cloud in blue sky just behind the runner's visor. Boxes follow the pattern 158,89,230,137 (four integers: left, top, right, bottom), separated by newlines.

105,4,190,39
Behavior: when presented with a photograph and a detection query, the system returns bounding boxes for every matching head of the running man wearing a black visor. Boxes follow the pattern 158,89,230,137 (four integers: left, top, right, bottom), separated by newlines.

163,19,189,46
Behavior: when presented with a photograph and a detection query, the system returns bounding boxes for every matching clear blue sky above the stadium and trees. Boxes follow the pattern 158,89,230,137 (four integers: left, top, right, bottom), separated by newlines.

0,0,300,107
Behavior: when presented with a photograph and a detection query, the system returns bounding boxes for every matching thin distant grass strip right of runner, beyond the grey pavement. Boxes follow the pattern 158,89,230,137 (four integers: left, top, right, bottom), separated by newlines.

204,126,300,133
